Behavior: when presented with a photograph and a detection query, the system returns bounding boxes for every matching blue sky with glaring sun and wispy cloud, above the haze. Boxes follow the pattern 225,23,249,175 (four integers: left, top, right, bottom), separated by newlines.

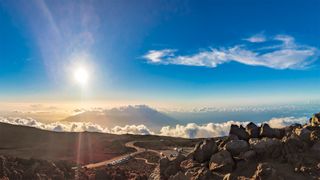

0,0,320,108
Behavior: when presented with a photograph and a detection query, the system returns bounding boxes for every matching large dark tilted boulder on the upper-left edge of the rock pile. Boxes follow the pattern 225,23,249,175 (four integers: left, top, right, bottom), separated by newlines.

193,139,218,163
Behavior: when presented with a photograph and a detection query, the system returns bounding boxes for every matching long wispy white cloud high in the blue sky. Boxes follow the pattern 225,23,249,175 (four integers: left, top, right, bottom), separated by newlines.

143,35,319,69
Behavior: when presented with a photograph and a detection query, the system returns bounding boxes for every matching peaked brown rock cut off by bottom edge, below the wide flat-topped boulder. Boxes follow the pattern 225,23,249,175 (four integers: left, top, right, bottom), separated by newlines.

252,163,283,180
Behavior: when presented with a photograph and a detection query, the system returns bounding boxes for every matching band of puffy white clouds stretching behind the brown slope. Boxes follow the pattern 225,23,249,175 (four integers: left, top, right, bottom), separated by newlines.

0,117,308,138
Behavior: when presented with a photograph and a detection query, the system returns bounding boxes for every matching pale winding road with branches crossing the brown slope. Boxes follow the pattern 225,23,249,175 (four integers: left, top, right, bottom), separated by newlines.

82,141,160,169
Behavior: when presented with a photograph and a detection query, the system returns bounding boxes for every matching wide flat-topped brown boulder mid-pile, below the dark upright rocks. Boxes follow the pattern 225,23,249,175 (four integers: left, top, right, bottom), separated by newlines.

249,138,282,158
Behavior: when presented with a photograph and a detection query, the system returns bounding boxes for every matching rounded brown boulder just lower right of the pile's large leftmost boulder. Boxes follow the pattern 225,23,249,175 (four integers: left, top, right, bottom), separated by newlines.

209,150,235,172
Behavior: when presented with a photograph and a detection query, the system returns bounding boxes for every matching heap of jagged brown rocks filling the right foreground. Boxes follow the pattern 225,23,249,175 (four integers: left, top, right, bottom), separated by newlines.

150,114,320,180
